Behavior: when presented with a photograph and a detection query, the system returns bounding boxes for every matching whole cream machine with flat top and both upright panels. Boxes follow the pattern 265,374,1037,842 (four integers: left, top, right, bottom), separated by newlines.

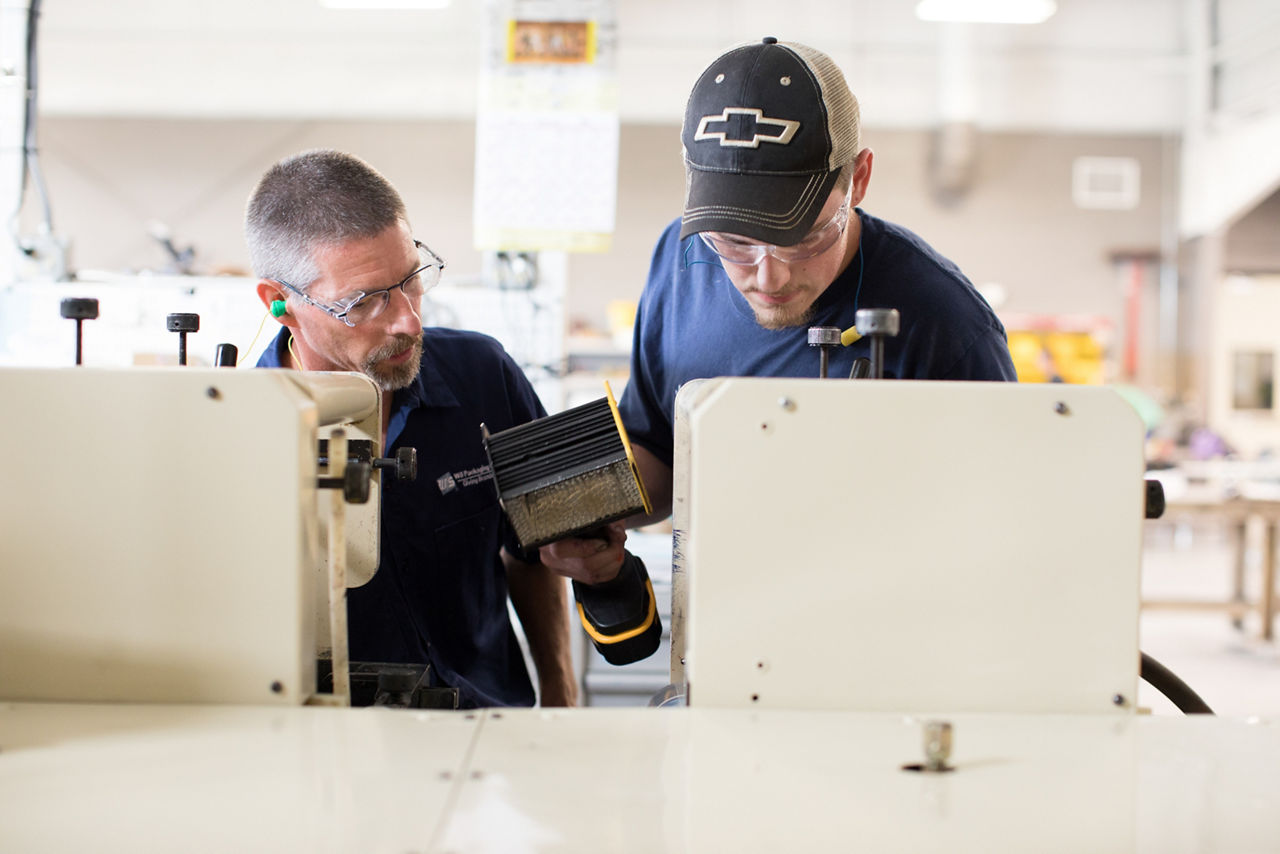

0,367,1280,854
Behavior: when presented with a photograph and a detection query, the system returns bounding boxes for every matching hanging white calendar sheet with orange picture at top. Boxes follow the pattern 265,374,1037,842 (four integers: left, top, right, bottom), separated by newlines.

474,0,618,252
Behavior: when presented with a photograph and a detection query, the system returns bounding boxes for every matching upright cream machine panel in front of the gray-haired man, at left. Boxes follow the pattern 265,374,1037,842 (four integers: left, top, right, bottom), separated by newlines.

0,367,378,704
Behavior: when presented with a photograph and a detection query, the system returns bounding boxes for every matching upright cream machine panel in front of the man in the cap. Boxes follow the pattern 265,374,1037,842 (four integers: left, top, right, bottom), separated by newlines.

682,379,1144,713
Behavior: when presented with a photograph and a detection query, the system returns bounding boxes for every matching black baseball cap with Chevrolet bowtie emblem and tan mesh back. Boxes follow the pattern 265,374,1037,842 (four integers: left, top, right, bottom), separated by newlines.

680,37,859,246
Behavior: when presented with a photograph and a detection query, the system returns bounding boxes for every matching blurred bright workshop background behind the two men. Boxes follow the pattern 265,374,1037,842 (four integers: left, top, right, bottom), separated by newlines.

0,0,1280,714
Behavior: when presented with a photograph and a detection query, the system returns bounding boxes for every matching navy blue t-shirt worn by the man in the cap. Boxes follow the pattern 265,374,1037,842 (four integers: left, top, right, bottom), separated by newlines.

618,209,1018,465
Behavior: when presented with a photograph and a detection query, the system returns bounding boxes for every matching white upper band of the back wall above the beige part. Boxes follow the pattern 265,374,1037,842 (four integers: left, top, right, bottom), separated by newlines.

27,0,1208,133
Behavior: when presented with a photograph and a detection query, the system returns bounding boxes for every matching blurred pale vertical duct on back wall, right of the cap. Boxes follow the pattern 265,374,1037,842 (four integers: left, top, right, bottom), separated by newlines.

928,23,979,206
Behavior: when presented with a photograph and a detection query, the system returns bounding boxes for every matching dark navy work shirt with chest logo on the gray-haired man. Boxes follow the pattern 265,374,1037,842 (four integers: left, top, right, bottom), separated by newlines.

257,328,547,707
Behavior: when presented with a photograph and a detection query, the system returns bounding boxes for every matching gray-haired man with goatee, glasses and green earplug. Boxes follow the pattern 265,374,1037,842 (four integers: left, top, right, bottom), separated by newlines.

244,150,576,707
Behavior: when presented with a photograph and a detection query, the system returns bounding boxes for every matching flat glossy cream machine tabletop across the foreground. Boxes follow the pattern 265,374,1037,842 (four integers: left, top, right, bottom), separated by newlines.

0,703,1280,854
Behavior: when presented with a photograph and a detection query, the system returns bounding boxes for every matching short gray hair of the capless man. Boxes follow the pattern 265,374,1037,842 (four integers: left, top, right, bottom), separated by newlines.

244,149,408,289
